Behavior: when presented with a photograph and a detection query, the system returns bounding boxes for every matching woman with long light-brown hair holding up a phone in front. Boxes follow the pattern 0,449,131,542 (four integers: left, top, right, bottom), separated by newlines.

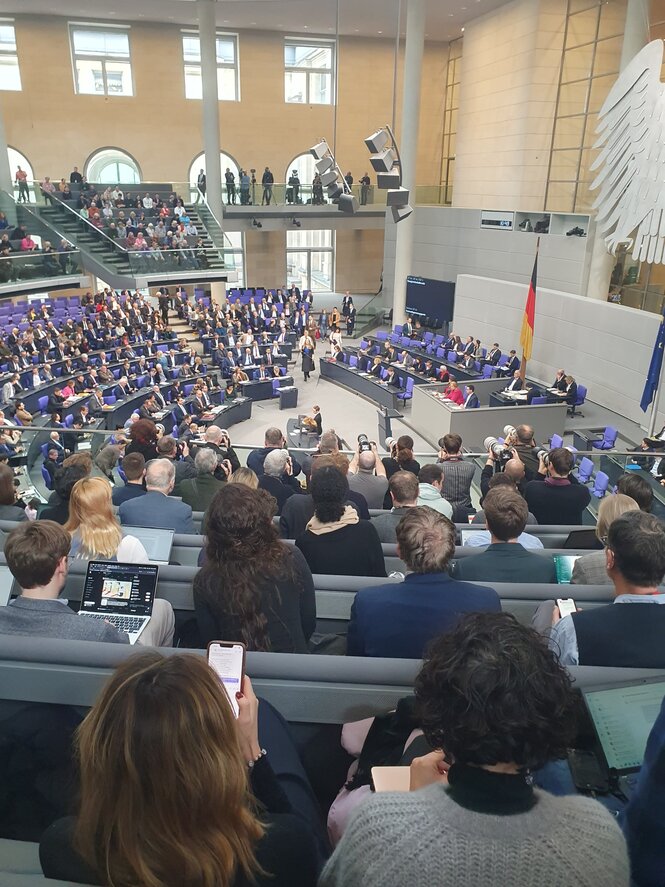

40,652,317,887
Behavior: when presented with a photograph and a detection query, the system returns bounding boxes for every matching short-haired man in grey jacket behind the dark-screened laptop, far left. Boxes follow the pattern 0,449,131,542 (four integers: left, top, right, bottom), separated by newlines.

0,520,175,647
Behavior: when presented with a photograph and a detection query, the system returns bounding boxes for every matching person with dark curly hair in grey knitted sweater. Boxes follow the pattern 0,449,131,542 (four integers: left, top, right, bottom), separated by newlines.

319,613,630,887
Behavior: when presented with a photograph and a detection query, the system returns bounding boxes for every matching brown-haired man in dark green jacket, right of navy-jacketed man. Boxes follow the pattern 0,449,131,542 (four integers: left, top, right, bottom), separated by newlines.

454,486,556,584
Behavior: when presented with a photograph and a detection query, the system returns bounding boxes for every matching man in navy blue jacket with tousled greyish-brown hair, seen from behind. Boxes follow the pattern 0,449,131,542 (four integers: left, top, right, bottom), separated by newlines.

347,506,501,659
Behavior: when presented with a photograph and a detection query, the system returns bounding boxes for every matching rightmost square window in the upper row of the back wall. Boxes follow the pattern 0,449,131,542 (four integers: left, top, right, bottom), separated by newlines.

284,37,335,105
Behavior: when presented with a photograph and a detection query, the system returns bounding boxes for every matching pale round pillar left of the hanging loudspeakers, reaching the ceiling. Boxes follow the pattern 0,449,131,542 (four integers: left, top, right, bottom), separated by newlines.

196,0,224,225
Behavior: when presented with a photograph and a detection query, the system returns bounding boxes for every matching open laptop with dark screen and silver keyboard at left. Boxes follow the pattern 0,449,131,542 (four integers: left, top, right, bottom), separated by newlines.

79,561,159,644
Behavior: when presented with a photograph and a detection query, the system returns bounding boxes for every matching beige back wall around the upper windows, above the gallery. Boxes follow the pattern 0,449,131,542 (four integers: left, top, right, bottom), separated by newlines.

0,15,447,183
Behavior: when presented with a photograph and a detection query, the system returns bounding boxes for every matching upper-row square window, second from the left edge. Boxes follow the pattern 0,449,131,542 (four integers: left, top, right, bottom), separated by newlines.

70,25,134,95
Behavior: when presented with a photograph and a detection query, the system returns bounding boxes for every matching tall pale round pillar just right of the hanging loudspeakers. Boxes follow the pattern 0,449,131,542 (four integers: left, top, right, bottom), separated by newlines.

393,0,426,323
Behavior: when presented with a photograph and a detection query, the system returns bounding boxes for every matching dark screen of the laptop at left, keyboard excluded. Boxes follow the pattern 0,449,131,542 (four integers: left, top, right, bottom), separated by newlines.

81,561,159,616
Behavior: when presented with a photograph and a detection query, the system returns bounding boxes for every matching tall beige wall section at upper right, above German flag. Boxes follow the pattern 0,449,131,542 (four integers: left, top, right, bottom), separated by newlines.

453,0,566,209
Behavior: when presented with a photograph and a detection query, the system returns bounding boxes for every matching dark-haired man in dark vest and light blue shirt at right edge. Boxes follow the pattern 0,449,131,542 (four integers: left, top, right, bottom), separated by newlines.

549,511,665,668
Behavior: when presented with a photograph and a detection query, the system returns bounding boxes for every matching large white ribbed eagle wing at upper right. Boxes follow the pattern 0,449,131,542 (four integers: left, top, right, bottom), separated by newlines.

591,40,665,262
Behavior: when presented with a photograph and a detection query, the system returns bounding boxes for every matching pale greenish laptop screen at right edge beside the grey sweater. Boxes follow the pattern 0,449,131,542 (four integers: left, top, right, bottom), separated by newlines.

584,678,665,771
